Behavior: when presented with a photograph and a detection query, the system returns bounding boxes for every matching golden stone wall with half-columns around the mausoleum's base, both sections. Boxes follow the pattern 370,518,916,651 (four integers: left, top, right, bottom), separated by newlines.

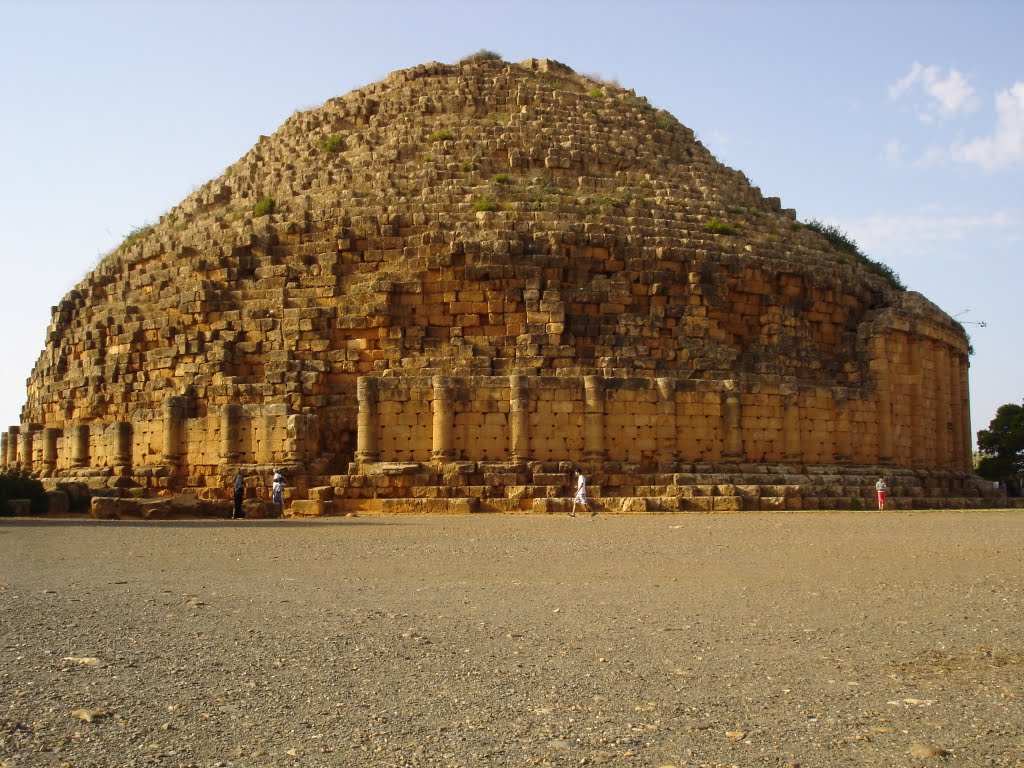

4,321,971,489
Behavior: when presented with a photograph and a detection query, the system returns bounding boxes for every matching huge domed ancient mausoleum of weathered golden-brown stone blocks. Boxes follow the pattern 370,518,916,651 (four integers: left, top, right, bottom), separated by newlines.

0,59,999,514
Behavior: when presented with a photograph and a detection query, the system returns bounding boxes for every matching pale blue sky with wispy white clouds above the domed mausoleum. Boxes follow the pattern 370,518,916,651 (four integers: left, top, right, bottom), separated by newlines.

0,0,1024,450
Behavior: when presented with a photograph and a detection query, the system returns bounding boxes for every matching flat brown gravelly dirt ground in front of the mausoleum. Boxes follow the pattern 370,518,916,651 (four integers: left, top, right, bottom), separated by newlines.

0,512,1024,768
